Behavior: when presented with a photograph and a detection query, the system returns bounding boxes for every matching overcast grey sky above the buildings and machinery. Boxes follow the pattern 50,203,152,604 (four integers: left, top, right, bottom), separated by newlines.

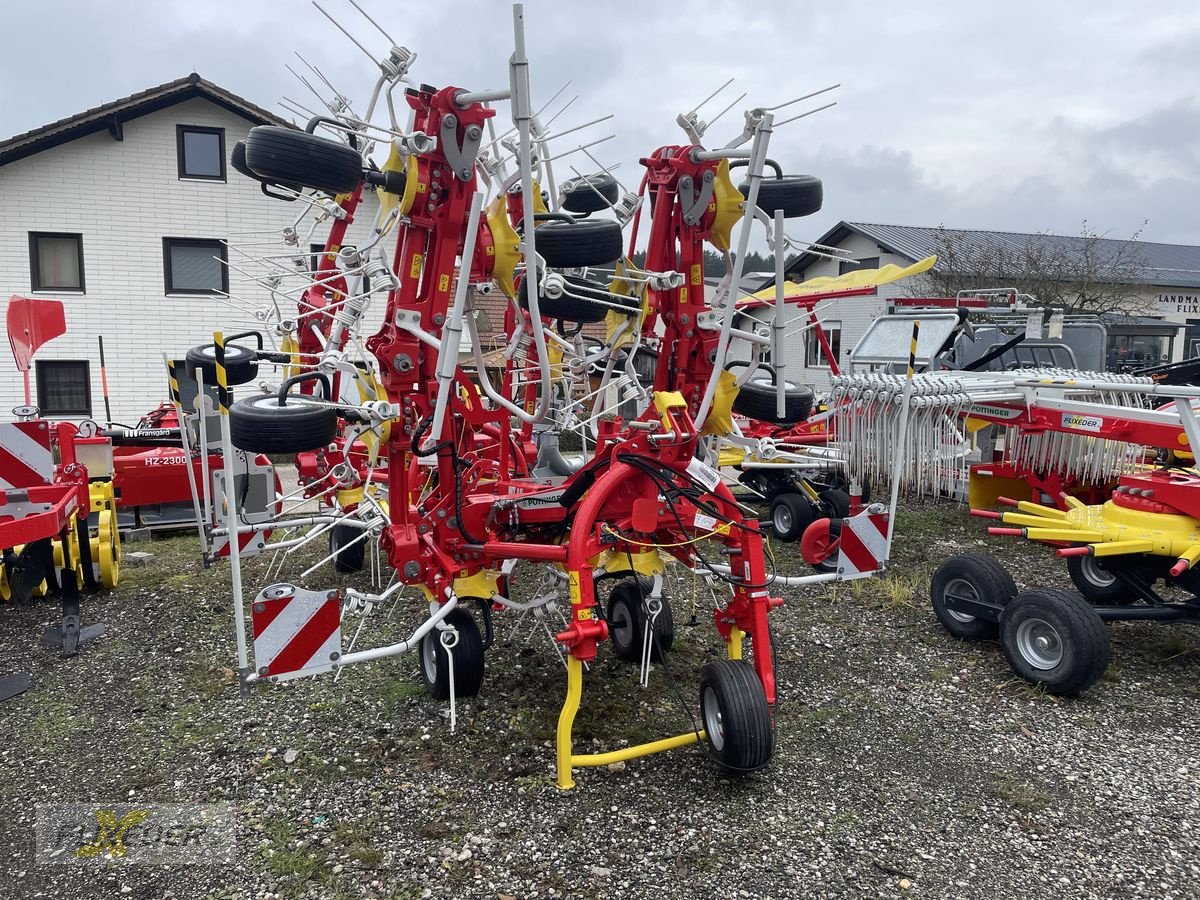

0,0,1200,244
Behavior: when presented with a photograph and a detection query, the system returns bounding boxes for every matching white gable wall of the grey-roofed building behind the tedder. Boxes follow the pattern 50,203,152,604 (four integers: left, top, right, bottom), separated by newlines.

734,234,920,396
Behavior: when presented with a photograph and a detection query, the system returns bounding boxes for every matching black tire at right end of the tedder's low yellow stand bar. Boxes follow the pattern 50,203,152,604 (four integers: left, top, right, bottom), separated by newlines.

700,659,775,774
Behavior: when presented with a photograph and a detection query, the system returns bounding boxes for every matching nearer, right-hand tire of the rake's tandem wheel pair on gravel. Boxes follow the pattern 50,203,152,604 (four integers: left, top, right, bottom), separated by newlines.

1000,588,1111,696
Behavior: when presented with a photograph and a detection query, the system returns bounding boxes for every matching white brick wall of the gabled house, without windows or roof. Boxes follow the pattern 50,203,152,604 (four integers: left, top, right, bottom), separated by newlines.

0,98,380,424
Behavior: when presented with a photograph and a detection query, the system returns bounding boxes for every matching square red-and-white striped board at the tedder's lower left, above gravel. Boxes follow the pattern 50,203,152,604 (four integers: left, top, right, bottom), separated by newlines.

251,584,342,682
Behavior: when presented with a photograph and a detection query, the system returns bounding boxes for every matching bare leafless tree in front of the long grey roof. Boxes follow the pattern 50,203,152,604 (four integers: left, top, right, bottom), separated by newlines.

908,220,1148,314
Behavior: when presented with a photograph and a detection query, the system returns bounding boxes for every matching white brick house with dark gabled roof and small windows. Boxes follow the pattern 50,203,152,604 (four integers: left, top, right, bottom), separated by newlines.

0,73,377,424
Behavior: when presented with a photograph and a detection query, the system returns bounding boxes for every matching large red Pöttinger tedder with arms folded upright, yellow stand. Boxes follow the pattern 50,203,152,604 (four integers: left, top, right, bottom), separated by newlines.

175,5,894,788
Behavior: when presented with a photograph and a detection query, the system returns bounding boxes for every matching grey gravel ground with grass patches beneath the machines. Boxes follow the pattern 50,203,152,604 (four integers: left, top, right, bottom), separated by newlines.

0,504,1200,900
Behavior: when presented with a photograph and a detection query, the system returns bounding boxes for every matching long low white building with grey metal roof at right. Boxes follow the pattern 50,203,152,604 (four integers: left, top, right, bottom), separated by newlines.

756,222,1200,392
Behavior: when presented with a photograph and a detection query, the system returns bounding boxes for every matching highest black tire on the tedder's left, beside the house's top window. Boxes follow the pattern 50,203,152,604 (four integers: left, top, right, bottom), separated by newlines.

246,125,362,194
